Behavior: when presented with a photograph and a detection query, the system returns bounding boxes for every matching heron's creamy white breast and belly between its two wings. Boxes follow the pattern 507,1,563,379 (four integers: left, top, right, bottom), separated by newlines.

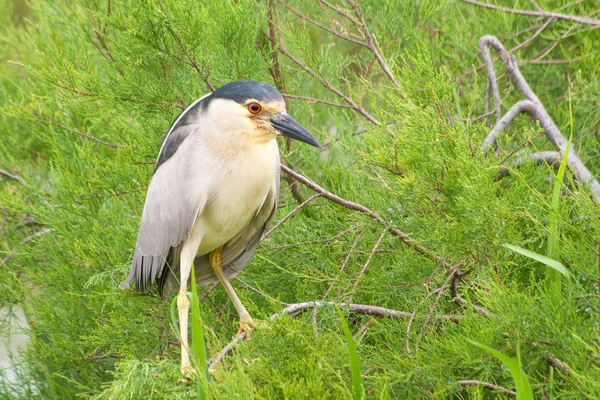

191,141,278,253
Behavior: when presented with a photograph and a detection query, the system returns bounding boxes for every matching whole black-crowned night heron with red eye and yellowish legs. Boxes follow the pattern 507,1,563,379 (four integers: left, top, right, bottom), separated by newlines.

121,81,319,374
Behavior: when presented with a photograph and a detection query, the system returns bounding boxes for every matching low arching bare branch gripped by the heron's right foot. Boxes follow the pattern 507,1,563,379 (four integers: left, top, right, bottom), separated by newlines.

208,301,460,374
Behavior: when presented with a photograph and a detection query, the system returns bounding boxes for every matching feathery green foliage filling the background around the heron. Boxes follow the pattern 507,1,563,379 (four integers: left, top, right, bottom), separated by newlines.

0,0,600,399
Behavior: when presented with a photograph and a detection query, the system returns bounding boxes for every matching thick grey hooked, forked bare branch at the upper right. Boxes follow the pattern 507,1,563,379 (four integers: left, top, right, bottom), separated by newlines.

478,35,600,203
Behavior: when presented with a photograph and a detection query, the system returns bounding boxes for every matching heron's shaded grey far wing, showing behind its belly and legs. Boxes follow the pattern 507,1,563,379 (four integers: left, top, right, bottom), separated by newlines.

159,155,279,297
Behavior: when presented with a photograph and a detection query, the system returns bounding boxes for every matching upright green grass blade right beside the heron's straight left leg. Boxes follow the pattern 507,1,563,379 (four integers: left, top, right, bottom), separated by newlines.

192,265,208,399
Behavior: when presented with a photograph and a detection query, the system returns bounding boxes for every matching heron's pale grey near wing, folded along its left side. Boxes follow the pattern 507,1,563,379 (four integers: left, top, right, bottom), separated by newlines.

121,96,206,292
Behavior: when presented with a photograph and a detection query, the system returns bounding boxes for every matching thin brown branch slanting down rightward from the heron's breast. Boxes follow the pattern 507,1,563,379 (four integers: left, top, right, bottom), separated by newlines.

281,164,451,269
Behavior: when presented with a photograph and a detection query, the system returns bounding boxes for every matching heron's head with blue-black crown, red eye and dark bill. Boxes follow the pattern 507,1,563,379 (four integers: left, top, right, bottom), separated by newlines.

203,81,320,147
